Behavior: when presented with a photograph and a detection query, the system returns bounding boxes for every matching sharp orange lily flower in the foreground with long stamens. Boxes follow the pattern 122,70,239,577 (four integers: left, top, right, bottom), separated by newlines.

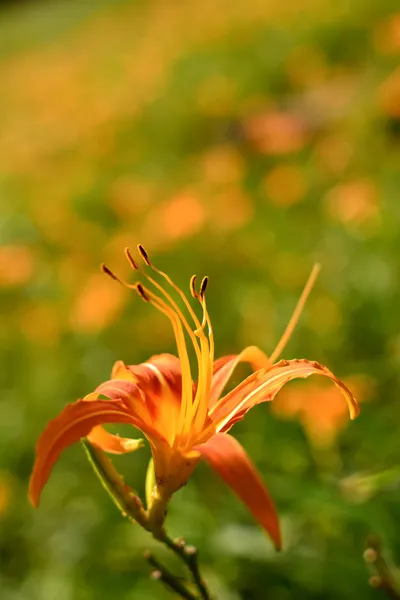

30,246,358,548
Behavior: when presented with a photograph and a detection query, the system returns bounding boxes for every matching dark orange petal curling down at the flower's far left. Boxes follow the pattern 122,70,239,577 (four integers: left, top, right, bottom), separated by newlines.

29,399,162,506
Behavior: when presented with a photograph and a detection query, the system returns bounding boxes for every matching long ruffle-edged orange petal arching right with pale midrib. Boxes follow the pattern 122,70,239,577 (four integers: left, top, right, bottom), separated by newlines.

210,359,359,431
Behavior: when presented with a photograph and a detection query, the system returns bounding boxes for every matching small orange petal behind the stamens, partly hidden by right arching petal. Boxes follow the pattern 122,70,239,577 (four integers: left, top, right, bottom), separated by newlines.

209,346,272,408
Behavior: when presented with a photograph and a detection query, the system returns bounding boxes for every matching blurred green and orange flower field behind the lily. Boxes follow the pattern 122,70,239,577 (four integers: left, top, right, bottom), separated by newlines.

0,0,400,600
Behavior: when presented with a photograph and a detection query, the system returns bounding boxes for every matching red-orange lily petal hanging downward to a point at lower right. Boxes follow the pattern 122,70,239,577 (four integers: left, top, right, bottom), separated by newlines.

193,433,282,550
